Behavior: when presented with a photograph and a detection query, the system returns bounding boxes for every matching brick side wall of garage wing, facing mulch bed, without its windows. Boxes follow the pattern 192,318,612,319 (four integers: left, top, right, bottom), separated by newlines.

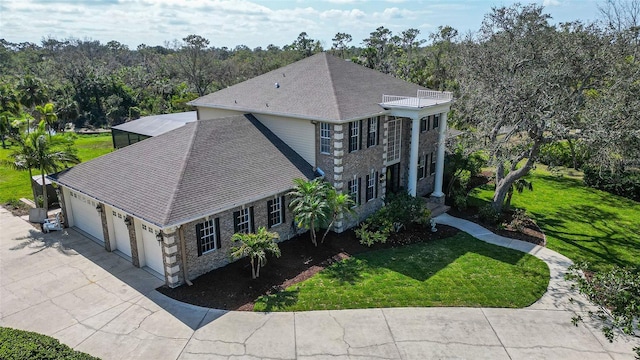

172,194,298,286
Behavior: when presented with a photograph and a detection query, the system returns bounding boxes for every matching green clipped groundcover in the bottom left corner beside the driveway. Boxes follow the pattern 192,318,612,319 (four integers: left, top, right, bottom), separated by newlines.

0,327,99,360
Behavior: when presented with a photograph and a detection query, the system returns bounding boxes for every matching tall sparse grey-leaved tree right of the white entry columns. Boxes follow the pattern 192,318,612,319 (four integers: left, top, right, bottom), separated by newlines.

454,4,608,211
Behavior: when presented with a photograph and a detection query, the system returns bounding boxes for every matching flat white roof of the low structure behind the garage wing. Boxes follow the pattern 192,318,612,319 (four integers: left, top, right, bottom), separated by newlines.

112,111,198,136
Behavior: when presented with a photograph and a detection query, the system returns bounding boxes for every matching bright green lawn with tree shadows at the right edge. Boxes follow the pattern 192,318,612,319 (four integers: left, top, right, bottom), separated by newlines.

472,168,640,270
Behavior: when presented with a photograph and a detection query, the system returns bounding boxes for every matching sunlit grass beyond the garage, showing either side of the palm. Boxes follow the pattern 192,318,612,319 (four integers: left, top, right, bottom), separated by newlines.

0,134,113,204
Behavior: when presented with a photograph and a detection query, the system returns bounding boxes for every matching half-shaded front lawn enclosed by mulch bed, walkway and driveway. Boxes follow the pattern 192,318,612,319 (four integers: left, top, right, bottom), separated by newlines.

254,233,549,311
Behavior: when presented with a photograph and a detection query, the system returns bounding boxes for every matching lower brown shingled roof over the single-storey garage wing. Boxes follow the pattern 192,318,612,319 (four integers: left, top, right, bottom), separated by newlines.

50,114,314,227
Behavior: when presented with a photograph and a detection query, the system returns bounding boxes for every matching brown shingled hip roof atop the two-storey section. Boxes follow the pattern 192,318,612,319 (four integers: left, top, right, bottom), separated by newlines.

189,53,424,122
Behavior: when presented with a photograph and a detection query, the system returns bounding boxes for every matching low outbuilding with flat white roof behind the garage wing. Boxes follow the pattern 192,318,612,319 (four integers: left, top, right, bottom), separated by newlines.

111,111,198,149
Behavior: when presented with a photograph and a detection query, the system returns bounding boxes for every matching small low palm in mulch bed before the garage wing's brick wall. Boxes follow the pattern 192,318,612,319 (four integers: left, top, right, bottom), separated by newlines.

229,226,280,279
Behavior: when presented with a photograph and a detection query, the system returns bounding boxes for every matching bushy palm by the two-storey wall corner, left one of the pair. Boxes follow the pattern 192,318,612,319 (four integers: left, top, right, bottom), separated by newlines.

289,179,331,246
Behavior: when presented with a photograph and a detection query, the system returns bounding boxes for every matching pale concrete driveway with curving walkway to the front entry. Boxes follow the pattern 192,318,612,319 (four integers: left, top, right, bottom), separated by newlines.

0,208,638,360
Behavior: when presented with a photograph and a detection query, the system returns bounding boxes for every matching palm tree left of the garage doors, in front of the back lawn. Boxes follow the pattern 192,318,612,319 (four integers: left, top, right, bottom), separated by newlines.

5,120,80,209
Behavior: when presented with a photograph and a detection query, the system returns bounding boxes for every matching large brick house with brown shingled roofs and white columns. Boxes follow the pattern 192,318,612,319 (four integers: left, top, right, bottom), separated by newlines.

51,53,452,287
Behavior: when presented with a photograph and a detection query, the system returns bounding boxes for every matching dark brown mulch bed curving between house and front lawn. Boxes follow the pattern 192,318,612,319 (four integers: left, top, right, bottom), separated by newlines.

158,225,459,311
